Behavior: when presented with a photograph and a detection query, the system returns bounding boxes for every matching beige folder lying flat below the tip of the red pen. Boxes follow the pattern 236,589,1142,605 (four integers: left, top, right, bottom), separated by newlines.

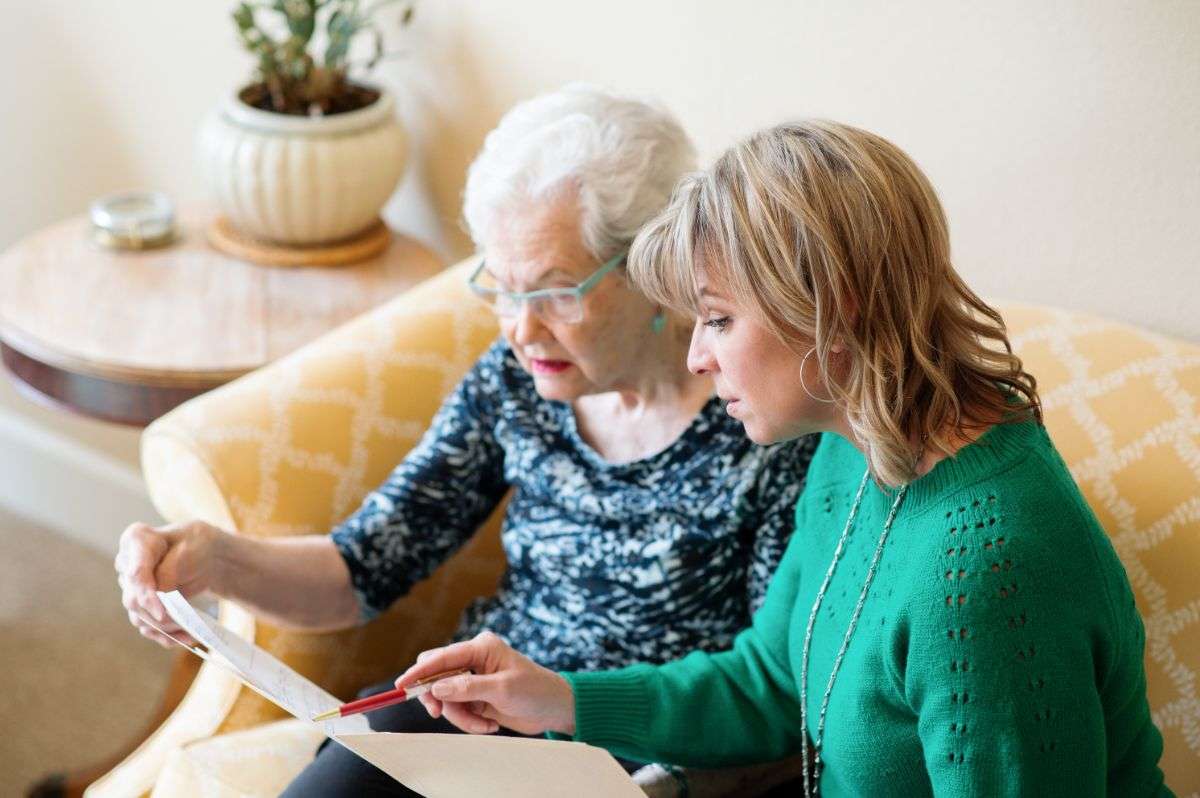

337,732,646,798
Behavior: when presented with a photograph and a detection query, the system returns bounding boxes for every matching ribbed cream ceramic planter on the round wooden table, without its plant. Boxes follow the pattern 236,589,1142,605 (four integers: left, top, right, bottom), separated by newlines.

198,85,407,245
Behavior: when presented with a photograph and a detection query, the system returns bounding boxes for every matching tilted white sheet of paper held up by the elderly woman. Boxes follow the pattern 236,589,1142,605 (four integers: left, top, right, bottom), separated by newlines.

158,590,371,737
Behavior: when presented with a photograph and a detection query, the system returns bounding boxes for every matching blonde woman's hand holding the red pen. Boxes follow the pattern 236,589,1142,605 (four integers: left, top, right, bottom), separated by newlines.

396,631,575,734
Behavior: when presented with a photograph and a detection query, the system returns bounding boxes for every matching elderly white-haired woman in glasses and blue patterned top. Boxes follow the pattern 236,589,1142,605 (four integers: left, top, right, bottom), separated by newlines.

116,86,814,796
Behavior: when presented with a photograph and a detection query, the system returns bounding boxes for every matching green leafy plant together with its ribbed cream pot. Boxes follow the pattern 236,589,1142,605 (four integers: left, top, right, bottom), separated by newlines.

198,0,413,246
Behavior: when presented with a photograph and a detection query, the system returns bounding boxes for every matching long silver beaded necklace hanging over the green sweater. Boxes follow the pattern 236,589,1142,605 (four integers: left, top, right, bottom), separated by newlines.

800,468,908,798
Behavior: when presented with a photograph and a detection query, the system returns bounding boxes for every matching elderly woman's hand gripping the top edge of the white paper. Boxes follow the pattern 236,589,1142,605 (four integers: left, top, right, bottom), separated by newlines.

113,521,224,648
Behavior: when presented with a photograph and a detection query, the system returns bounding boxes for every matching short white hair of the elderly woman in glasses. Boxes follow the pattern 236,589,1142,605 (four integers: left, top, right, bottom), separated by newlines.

463,83,696,259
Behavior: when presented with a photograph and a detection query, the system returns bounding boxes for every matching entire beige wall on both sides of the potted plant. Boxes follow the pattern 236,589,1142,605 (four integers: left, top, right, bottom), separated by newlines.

0,0,1200,489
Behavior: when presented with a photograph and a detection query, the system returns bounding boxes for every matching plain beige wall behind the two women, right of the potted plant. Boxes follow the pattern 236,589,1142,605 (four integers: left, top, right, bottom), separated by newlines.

396,0,1200,340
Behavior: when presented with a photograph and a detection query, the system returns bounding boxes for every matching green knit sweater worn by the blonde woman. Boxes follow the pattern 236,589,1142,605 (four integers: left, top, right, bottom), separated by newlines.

564,421,1170,797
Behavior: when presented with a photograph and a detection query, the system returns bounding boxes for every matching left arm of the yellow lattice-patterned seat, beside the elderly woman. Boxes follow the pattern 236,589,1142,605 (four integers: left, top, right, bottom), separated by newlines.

89,262,504,796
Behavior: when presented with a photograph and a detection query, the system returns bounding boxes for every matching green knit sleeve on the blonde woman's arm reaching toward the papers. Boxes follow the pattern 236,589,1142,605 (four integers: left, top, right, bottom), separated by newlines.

563,528,802,768
